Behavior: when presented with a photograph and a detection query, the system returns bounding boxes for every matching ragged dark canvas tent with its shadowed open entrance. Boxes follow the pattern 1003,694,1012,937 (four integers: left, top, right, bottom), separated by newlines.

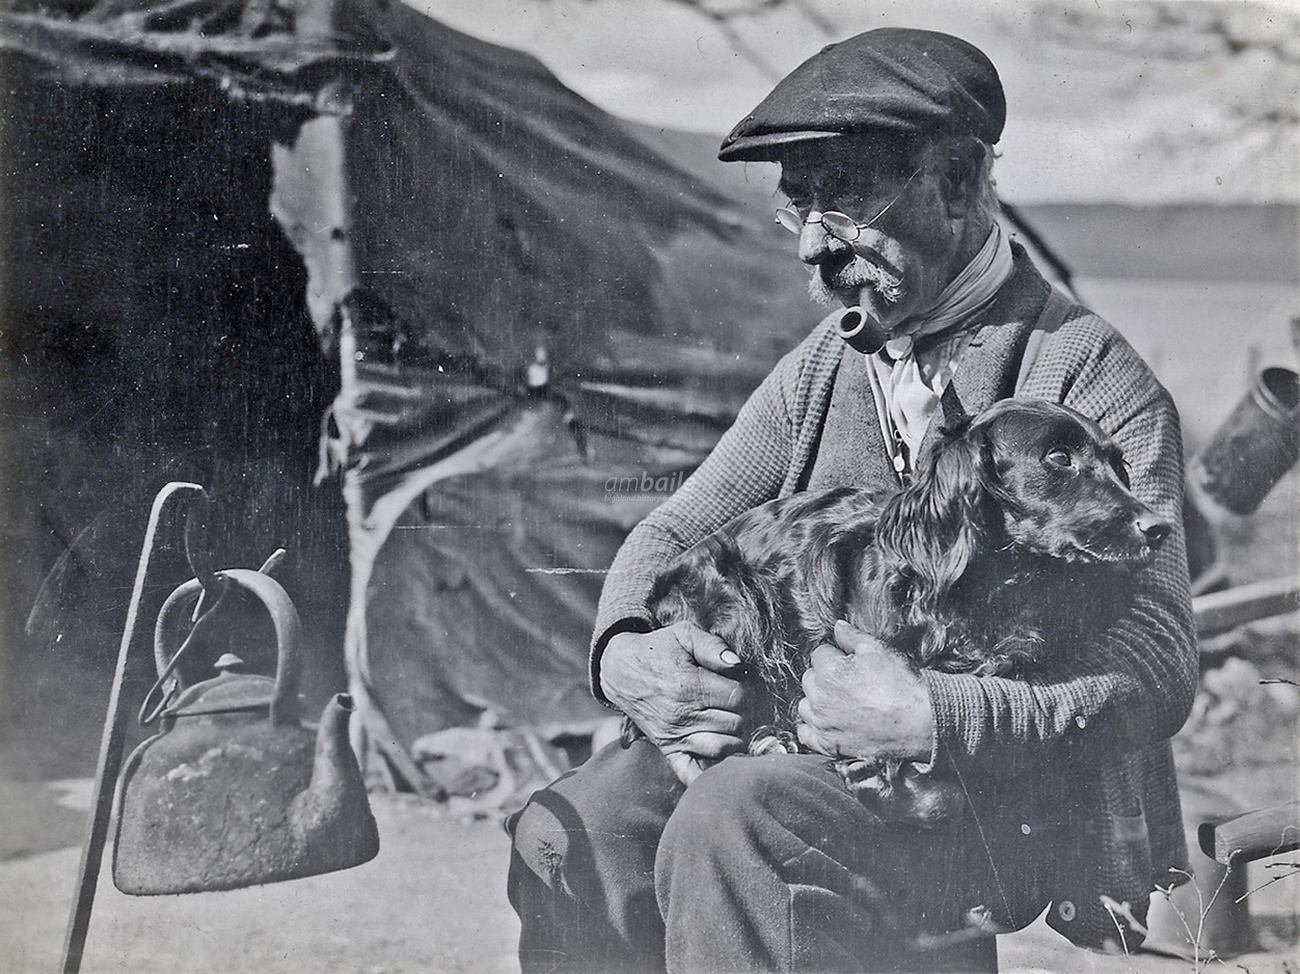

0,0,818,776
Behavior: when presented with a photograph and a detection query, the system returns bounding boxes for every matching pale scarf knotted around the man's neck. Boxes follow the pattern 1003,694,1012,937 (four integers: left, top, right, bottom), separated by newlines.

871,222,1011,471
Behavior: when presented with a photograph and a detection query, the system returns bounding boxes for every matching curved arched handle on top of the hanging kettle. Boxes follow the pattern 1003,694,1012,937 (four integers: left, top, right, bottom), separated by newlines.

153,568,303,727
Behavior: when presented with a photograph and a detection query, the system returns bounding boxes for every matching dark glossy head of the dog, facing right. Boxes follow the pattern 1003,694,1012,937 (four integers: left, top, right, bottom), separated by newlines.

930,399,1173,567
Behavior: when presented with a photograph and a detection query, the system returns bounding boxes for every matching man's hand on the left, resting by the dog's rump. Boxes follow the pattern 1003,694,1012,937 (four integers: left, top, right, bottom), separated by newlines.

601,623,745,761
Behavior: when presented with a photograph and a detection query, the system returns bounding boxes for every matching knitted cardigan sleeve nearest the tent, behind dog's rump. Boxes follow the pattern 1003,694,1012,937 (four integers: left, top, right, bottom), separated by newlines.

590,333,816,705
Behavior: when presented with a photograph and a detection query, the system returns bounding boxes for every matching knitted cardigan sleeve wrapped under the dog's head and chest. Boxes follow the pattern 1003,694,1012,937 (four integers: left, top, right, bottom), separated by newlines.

924,315,1197,758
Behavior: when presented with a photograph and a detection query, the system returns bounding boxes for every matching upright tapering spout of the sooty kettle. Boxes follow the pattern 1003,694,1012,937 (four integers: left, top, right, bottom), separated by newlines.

290,693,380,862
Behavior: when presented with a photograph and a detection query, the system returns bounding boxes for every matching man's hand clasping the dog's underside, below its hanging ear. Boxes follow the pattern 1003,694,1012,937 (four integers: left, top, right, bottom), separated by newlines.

798,622,935,763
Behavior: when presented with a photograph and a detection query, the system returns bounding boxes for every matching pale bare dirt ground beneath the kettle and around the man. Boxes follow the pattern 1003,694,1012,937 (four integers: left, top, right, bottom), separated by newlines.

0,780,1300,974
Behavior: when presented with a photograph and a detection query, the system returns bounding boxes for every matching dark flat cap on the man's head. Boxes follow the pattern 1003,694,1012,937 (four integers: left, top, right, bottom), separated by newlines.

718,27,1006,161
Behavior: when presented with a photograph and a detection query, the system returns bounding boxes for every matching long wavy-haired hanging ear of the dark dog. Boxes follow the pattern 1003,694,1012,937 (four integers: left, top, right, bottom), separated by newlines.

878,421,992,637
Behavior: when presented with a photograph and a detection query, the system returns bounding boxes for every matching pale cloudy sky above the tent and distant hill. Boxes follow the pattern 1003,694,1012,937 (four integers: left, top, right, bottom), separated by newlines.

407,0,1300,203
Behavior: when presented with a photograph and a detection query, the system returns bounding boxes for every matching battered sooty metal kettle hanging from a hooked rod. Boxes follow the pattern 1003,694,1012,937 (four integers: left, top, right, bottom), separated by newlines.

113,568,380,896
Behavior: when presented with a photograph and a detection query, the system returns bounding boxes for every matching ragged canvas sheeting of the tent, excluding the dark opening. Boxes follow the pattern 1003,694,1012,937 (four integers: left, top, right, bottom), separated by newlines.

0,0,818,780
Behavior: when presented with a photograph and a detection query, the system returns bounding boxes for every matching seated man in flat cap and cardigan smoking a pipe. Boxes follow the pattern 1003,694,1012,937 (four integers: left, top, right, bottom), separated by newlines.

510,30,1196,971
